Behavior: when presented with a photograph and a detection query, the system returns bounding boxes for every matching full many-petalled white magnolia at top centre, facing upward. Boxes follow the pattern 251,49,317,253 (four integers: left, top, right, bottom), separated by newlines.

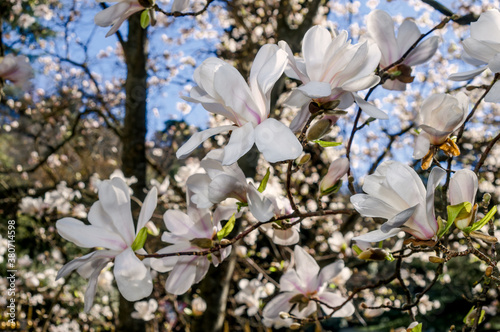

279,26,388,131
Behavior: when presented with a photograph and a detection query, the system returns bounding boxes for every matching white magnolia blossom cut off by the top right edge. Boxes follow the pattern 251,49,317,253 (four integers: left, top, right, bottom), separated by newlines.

449,9,500,103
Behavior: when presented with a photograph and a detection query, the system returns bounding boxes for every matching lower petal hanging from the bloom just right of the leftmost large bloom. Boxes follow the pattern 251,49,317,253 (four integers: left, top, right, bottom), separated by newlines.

165,256,200,295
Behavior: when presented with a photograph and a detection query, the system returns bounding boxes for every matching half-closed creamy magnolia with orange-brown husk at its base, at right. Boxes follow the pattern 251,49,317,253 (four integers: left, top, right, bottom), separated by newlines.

413,92,469,159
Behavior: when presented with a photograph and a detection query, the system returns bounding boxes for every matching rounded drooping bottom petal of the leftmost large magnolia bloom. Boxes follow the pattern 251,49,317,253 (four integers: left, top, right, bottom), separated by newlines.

113,248,153,302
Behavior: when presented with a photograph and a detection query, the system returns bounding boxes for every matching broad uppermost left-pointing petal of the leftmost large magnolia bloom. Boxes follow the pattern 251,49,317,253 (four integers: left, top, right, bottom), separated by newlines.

56,218,127,251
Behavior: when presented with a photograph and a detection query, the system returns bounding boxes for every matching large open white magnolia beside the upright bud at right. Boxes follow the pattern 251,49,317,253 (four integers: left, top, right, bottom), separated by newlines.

351,161,446,242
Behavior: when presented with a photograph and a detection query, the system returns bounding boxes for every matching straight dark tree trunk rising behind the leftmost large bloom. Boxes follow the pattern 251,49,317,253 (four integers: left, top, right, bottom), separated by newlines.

117,13,147,331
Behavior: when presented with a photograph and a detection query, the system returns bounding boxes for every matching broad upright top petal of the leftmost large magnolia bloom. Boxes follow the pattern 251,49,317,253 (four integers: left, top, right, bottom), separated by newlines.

99,177,135,245
